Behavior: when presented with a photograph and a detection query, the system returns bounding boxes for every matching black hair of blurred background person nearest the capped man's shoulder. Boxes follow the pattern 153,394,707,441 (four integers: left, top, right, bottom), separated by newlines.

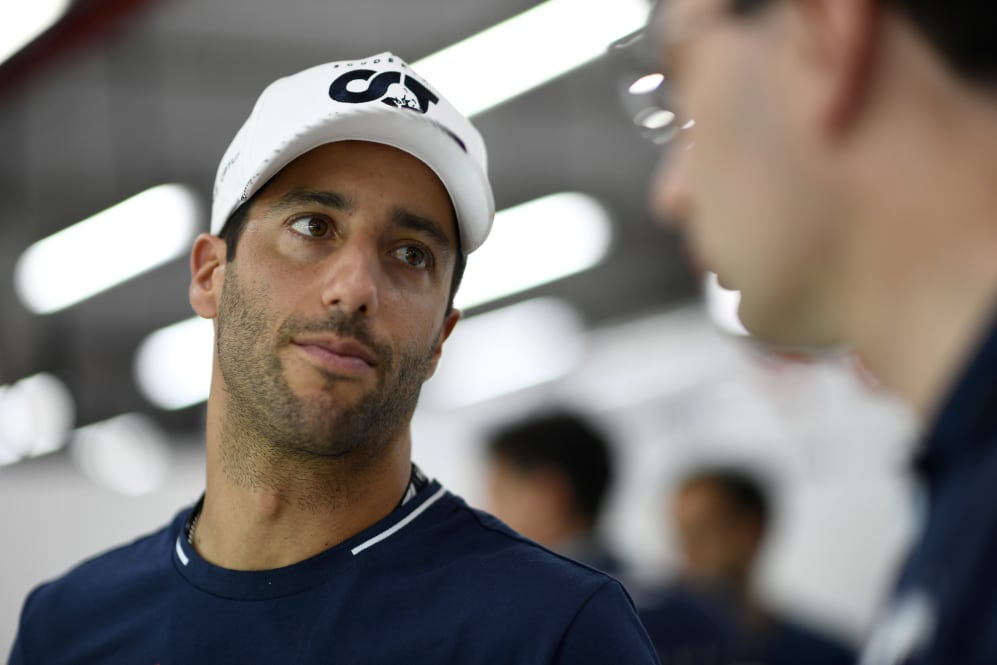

488,410,613,523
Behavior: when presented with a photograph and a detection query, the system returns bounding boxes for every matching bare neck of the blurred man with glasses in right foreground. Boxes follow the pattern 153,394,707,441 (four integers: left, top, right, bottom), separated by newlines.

841,141,997,422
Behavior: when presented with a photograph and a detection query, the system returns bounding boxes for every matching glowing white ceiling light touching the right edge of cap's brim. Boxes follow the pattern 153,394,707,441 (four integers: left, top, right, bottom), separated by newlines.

454,192,612,308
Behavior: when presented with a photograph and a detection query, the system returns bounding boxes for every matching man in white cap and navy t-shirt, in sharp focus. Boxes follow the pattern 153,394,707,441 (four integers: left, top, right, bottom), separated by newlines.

10,53,655,665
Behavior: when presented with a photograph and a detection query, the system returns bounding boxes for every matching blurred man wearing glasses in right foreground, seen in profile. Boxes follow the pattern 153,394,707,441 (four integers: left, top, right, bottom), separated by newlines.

624,0,997,665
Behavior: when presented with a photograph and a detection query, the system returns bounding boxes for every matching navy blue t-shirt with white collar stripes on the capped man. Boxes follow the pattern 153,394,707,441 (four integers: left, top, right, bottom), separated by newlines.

10,481,657,665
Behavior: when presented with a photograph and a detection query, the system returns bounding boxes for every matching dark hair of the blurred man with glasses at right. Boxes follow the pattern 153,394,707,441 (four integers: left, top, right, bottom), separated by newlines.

729,0,997,85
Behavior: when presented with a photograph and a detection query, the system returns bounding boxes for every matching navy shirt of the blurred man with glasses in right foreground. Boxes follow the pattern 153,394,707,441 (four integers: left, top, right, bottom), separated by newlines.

862,312,997,665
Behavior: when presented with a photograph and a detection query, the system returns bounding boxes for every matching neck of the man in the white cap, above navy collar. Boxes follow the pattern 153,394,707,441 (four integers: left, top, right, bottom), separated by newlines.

192,416,411,570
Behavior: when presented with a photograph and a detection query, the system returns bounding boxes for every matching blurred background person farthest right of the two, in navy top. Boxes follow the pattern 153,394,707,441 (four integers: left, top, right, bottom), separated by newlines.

664,467,855,665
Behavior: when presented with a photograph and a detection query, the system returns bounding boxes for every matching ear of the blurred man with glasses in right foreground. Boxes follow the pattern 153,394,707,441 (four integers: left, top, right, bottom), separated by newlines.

793,0,882,135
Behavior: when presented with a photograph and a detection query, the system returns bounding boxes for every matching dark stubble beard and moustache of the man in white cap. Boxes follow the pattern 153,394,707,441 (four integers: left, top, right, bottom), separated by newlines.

216,264,440,471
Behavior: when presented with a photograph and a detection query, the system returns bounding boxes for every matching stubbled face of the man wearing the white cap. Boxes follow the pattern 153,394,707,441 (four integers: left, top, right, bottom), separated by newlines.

217,141,459,456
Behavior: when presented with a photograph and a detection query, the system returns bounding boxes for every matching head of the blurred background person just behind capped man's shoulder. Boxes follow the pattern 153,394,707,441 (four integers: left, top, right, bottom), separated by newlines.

487,410,623,576
